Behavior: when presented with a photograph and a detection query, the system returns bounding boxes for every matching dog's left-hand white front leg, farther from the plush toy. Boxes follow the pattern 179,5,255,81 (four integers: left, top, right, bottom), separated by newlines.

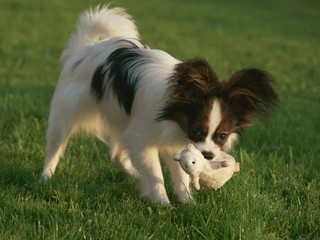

128,144,170,204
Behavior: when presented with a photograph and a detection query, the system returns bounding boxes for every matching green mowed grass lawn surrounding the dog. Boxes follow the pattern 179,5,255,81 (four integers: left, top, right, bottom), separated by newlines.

0,0,320,239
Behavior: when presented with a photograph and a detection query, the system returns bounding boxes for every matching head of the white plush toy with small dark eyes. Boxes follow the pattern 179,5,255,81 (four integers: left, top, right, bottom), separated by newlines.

174,144,204,176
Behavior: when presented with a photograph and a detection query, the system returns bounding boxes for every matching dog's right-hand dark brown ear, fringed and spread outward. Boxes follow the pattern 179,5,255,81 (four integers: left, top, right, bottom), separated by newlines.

223,69,278,127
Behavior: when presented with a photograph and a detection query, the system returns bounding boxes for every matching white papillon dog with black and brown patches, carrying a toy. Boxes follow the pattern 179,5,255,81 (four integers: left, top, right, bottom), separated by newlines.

42,6,278,204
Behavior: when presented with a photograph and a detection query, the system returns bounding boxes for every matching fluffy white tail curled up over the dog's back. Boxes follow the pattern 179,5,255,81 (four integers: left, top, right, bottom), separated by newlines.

60,6,140,64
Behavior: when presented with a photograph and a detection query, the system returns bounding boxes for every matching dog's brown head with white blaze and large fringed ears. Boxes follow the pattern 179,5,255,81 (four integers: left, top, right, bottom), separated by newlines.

159,58,278,160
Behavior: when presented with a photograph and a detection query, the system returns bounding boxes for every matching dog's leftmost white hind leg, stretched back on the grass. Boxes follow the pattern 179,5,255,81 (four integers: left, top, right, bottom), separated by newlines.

42,79,97,179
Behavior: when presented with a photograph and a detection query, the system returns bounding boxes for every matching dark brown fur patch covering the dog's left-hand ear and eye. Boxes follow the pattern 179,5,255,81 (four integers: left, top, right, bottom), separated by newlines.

158,58,219,142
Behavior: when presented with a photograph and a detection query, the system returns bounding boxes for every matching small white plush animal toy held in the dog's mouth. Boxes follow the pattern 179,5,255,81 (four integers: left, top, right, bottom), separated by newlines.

174,144,240,190
